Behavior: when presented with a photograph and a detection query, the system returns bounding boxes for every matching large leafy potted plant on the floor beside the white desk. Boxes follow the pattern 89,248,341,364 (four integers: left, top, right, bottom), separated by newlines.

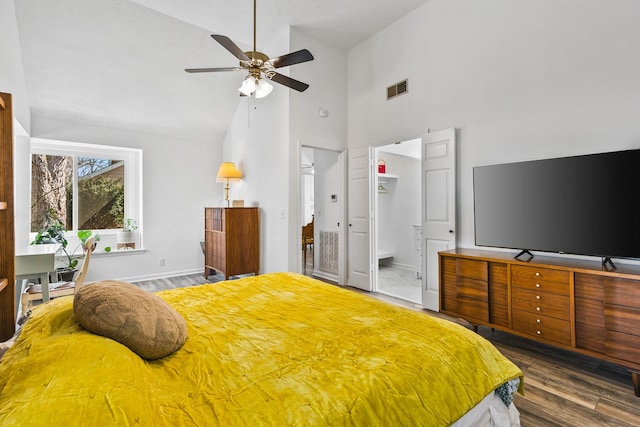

31,219,100,281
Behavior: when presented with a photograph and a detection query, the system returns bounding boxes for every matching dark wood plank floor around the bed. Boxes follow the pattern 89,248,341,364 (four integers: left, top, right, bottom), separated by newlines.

140,275,640,427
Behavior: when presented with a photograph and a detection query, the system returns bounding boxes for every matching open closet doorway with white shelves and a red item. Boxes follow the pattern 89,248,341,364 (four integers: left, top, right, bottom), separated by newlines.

374,138,422,304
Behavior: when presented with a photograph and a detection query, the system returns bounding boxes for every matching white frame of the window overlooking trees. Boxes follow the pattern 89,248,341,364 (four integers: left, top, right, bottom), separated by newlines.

29,138,142,235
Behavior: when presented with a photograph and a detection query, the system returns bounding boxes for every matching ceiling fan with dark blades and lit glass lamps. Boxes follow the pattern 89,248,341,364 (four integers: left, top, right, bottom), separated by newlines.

185,0,313,98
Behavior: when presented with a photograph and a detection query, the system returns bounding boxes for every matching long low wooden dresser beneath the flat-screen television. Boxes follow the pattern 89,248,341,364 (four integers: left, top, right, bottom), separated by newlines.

439,249,640,396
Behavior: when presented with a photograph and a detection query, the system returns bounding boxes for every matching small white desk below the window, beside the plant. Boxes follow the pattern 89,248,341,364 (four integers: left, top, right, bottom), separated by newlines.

16,244,61,304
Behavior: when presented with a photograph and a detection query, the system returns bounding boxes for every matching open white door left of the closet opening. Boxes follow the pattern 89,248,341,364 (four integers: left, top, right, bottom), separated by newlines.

347,147,373,292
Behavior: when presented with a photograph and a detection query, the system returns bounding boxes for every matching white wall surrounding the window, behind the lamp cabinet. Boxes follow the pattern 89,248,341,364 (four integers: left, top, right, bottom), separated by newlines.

0,0,222,281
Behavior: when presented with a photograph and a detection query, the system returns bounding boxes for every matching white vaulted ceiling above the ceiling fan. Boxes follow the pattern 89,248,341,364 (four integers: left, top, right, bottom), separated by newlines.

15,0,427,141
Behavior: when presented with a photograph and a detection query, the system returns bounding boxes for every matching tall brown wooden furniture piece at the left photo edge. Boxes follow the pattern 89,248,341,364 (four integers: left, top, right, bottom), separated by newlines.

0,92,16,341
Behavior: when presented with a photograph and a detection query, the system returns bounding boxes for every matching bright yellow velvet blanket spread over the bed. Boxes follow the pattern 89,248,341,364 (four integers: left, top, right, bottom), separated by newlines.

0,273,522,427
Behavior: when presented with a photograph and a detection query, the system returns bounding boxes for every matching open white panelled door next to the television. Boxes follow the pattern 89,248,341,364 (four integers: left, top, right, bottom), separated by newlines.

422,129,456,311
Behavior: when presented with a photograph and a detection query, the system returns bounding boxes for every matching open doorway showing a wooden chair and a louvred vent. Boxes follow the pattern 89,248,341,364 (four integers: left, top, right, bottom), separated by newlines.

300,146,344,283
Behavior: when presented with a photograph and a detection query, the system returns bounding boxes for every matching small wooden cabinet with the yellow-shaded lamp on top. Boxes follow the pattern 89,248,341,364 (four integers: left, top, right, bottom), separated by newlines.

204,208,260,279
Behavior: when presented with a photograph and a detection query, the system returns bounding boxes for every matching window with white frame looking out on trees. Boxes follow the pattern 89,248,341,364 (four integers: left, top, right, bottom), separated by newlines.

31,139,142,237
